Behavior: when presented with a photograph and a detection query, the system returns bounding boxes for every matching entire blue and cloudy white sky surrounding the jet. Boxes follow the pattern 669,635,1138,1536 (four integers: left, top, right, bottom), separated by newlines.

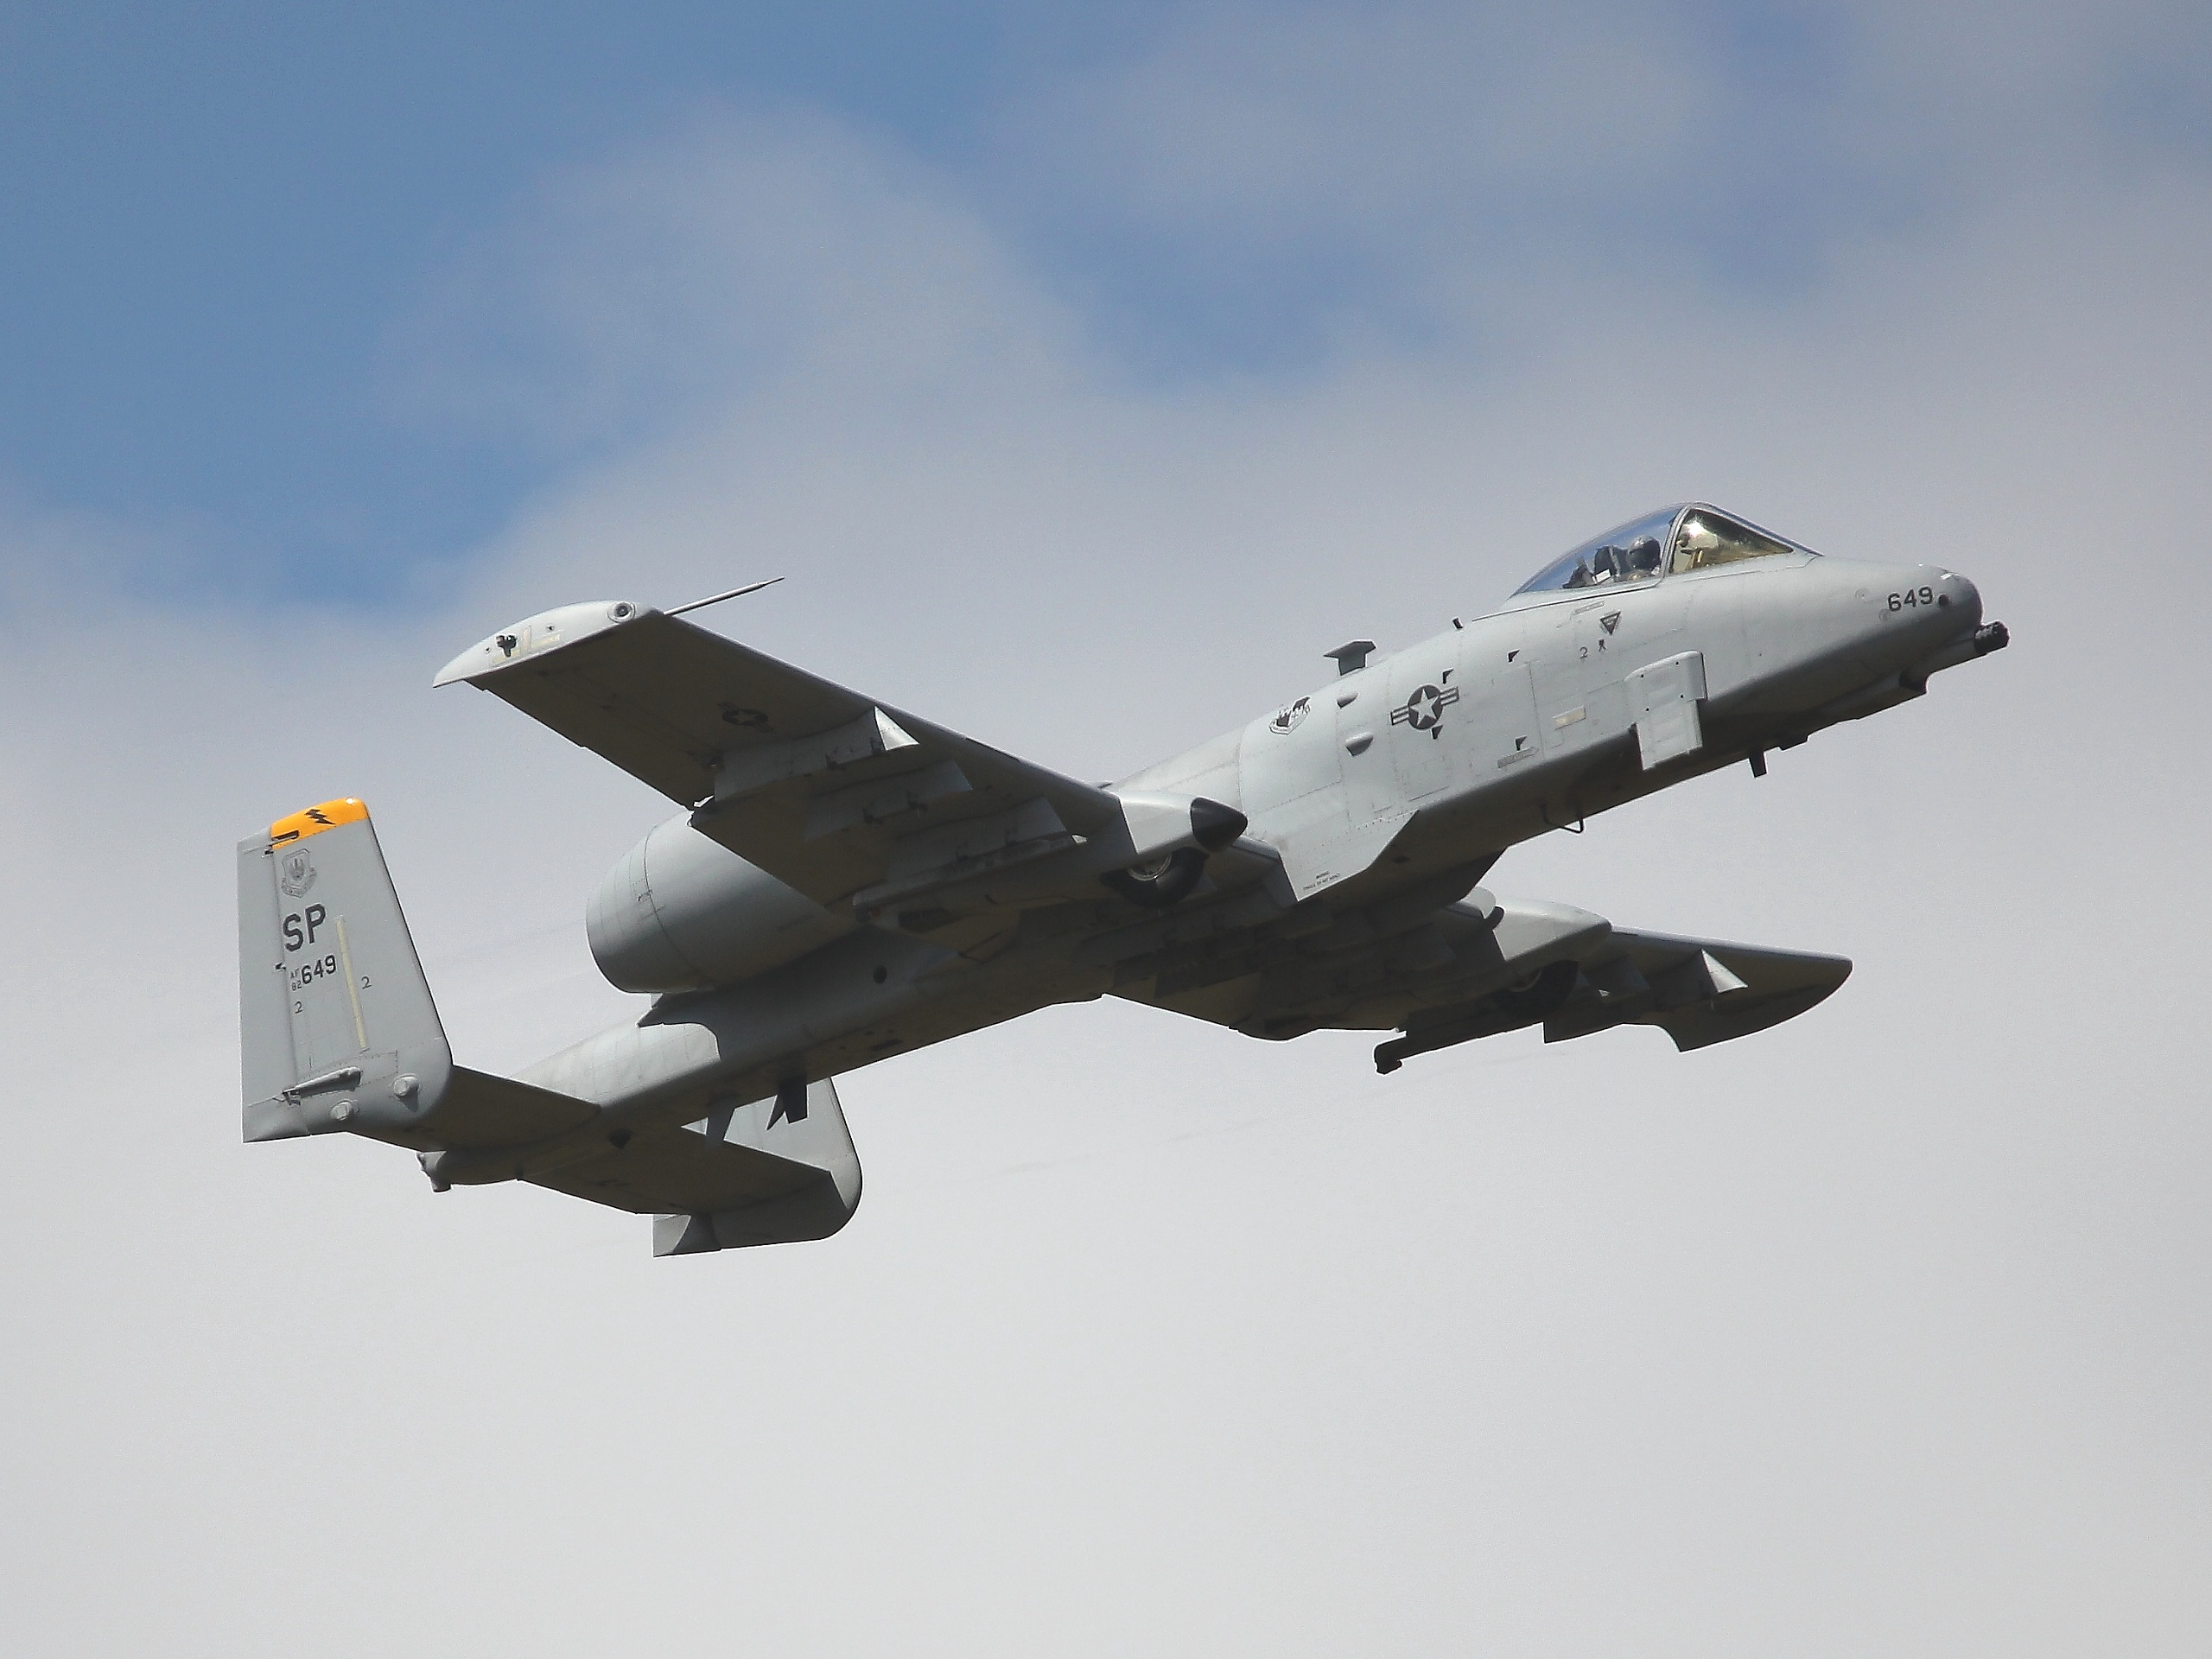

0,0,2212,1659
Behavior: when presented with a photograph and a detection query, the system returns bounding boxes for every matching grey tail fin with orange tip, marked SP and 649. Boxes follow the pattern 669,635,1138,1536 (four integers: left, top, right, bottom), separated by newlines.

238,798,454,1141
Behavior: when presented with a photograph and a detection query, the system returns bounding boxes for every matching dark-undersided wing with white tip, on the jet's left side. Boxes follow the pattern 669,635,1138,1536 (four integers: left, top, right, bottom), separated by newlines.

435,600,1122,905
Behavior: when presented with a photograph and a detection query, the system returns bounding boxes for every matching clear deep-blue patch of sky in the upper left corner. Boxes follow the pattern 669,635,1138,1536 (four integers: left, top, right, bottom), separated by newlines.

0,4,1026,593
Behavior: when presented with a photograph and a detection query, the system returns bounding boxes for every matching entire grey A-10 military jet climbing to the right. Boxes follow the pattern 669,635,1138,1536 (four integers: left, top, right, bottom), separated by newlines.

238,505,2006,1255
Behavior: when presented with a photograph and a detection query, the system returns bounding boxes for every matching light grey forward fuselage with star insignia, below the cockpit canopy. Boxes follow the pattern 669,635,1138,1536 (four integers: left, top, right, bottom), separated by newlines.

1117,539,1982,889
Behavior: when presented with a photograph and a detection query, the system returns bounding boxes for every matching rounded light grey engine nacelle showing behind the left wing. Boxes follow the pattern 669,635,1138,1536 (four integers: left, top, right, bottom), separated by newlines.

584,818,858,993
